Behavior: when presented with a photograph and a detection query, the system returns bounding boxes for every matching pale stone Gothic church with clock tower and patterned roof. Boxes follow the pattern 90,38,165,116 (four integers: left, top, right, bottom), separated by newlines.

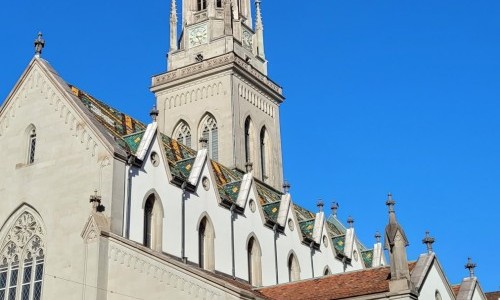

0,0,492,300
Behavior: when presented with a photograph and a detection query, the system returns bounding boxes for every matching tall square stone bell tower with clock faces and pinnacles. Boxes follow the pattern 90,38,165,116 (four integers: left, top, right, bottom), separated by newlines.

151,0,284,189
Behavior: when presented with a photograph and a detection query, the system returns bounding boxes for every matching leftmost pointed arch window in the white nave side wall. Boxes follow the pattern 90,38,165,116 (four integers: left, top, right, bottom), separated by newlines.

144,194,163,251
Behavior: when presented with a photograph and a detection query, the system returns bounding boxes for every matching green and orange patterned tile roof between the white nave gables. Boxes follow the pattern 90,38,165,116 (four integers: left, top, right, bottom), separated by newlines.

69,85,364,253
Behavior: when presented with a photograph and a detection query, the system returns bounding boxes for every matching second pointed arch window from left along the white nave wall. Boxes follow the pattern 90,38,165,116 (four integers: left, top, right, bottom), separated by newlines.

198,217,215,271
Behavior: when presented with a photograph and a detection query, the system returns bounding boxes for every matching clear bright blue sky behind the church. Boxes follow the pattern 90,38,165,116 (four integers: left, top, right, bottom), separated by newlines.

0,0,500,291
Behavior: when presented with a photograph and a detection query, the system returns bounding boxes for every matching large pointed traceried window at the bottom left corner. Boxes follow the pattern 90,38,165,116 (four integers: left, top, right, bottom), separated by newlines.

0,212,45,300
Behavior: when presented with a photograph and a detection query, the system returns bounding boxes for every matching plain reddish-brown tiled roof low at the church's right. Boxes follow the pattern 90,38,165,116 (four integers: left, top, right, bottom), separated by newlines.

258,262,415,300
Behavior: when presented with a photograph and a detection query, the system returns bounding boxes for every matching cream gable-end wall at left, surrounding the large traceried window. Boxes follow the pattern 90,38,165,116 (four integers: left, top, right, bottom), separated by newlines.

0,62,118,299
